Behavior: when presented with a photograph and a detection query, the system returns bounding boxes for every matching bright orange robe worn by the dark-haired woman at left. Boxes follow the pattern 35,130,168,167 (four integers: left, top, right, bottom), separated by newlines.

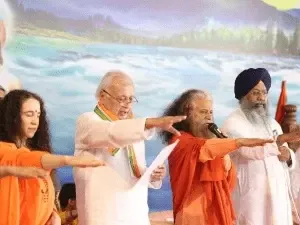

0,142,55,225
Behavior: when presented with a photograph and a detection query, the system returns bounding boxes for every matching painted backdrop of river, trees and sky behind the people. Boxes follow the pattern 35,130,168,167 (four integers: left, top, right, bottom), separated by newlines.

0,0,300,211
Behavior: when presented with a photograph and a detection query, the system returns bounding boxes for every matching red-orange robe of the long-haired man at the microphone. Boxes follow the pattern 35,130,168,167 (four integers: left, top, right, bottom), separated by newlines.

168,132,237,225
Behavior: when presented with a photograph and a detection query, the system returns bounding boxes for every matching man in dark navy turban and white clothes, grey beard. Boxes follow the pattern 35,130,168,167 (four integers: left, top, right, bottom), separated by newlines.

223,68,298,225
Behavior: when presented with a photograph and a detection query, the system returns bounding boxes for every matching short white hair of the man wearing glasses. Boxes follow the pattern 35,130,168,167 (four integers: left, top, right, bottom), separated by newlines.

95,70,133,99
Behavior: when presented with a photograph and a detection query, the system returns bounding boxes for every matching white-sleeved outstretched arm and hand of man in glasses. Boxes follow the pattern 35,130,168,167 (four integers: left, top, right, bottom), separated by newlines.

76,114,186,150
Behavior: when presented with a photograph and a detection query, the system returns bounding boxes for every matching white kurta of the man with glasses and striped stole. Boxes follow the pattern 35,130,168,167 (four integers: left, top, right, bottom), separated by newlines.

74,112,161,225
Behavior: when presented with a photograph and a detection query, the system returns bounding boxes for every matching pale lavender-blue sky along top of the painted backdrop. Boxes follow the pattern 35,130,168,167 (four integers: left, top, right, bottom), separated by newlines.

10,0,300,31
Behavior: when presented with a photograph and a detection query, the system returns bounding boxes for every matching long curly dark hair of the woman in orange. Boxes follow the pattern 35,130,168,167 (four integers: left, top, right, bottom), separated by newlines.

0,90,52,152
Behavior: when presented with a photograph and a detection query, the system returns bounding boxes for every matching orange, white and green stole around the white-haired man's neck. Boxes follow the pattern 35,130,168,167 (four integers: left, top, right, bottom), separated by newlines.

94,104,141,178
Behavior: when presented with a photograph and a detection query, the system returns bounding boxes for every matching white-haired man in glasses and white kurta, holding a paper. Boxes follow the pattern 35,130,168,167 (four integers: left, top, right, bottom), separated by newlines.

74,71,185,225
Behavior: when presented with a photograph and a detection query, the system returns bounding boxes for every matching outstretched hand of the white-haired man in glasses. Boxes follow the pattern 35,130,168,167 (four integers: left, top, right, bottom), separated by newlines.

145,116,186,135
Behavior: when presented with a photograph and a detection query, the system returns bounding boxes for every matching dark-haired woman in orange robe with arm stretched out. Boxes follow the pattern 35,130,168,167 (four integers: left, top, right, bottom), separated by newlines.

0,90,103,225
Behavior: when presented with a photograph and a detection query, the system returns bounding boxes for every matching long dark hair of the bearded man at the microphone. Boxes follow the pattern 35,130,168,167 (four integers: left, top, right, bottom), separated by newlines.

160,89,204,144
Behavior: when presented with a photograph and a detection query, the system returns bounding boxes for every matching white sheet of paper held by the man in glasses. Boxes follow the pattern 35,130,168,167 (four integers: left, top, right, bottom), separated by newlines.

134,140,179,187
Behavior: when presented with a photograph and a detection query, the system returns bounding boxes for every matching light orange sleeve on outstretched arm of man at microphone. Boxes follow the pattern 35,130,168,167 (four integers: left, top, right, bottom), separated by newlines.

199,138,238,163
